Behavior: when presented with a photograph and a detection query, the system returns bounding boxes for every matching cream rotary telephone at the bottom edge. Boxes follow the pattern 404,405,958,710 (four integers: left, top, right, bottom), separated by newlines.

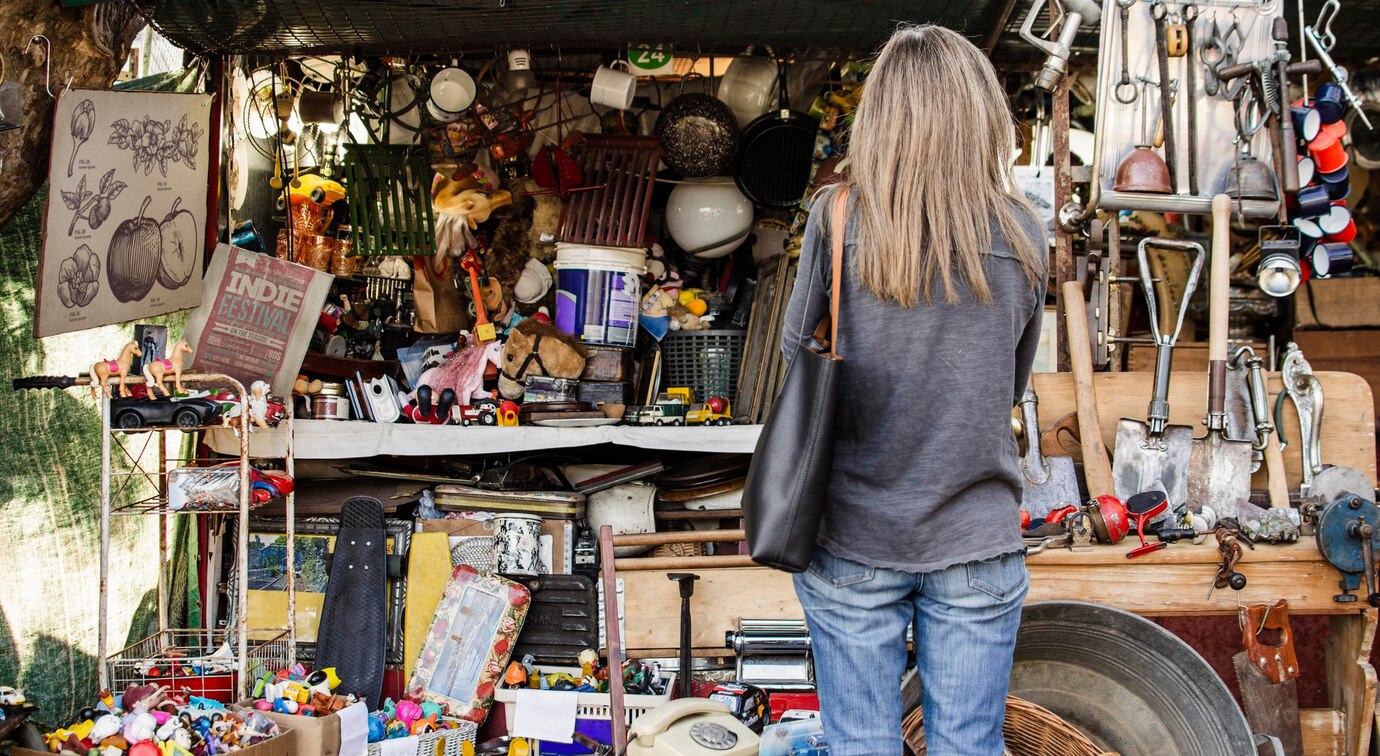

628,698,760,756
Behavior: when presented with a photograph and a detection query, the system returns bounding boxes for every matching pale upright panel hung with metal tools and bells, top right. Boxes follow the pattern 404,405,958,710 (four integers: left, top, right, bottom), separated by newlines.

1093,0,1282,218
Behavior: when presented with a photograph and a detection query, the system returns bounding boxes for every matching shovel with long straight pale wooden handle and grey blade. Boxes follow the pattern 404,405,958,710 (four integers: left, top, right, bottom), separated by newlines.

1187,195,1261,523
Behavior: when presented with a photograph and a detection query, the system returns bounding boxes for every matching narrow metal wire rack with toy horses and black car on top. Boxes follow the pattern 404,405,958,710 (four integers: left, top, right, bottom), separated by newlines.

93,374,297,701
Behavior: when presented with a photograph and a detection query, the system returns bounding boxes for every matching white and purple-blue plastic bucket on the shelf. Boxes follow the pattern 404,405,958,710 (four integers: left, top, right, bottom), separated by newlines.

556,244,647,346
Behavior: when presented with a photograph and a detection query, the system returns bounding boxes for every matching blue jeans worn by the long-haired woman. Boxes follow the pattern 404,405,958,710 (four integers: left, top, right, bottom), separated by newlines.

795,548,1029,756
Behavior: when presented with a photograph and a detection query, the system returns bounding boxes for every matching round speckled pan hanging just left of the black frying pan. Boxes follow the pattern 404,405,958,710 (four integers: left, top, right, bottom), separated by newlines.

654,73,738,178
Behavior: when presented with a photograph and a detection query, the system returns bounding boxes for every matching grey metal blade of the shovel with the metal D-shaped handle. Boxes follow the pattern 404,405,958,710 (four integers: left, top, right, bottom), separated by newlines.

1112,418,1194,509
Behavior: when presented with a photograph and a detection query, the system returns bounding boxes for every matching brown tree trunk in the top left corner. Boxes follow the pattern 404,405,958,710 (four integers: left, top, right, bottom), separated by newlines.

0,0,144,226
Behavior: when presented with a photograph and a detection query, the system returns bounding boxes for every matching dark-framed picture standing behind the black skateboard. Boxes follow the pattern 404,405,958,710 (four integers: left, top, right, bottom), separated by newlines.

225,517,413,664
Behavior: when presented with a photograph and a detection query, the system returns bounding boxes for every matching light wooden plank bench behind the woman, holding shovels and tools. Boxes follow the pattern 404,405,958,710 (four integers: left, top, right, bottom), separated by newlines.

620,372,1377,755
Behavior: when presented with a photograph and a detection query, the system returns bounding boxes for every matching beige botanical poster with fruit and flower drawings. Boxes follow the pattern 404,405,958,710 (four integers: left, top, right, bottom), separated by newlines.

35,90,211,338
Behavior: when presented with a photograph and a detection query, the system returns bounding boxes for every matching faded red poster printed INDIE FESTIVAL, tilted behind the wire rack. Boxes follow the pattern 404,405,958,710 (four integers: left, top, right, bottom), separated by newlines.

184,244,335,396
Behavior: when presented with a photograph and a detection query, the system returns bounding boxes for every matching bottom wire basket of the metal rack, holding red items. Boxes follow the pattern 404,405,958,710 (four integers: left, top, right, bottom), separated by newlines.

106,629,291,704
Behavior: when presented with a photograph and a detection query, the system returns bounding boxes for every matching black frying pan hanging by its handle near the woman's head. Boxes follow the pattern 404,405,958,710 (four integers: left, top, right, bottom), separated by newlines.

733,61,820,210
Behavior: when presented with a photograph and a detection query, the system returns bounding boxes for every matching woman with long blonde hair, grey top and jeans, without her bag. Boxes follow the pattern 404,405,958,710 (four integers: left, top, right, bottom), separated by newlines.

781,26,1047,756
